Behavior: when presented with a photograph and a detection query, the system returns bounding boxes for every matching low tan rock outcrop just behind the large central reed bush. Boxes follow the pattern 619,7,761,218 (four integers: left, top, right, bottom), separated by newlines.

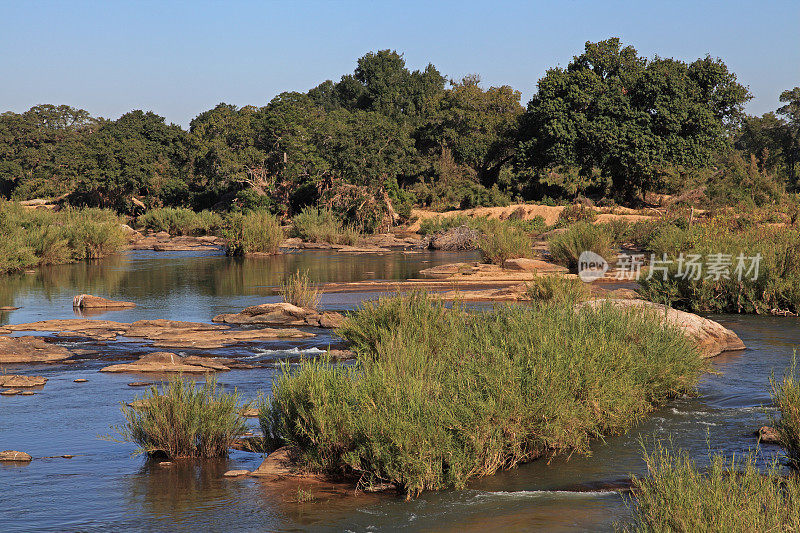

212,302,344,328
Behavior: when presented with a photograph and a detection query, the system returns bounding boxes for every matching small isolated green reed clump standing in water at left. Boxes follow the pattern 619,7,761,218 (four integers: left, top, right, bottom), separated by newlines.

114,377,247,458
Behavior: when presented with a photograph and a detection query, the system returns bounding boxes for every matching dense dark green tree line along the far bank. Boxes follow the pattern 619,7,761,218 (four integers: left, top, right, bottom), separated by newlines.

0,39,800,215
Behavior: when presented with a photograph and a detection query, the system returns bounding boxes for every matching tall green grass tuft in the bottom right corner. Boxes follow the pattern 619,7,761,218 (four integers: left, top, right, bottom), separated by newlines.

622,445,800,532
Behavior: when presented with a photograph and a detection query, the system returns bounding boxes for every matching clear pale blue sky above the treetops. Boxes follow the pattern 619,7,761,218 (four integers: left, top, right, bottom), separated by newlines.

0,0,800,126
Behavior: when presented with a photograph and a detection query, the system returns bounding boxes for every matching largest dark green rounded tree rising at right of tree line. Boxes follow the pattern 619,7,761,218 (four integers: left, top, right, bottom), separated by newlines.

517,38,750,201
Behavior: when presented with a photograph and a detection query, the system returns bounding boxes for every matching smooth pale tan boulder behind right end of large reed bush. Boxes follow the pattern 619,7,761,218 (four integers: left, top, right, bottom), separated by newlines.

578,298,745,357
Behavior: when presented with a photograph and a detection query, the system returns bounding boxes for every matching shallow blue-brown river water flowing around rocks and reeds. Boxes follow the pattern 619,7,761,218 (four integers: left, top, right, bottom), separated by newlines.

0,252,800,531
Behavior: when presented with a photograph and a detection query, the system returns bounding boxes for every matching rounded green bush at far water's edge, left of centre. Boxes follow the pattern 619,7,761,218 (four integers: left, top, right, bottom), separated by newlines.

223,211,283,255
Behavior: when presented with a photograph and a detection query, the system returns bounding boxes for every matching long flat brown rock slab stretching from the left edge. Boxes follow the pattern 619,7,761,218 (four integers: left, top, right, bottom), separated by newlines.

5,318,314,352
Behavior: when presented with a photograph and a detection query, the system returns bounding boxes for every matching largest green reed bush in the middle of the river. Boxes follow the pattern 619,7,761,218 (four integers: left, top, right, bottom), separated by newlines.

260,293,706,495
